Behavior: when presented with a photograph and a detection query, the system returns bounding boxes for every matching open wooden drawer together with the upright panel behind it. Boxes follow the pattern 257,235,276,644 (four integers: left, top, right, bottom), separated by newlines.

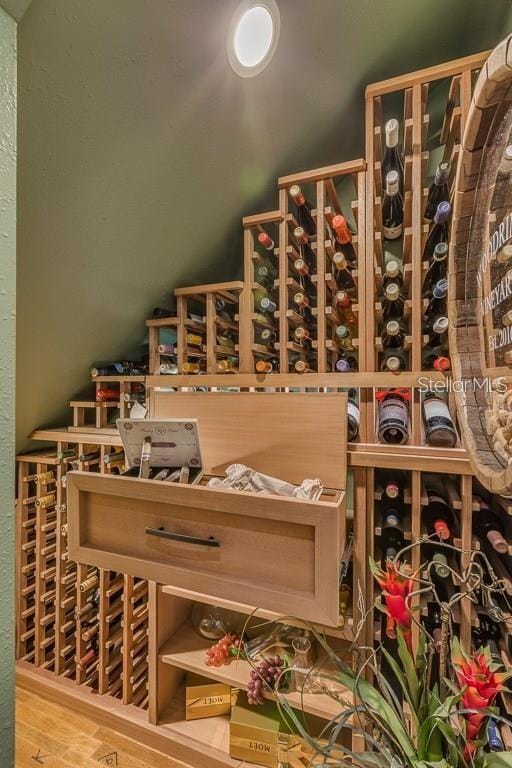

68,392,346,626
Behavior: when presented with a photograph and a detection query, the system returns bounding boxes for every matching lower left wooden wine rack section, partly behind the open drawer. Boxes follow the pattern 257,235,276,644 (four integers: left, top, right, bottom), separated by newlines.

16,430,148,708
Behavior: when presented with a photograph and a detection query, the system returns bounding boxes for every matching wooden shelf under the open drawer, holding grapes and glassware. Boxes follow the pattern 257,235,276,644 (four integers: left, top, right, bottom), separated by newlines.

159,624,351,720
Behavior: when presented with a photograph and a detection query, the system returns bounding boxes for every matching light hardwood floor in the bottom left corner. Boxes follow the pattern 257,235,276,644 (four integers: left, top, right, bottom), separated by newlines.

16,688,192,768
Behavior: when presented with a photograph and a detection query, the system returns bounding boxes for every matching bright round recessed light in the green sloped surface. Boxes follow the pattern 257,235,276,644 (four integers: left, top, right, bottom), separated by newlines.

228,0,279,77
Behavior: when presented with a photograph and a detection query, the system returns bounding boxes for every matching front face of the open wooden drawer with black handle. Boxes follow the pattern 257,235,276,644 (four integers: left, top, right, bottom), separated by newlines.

68,472,344,626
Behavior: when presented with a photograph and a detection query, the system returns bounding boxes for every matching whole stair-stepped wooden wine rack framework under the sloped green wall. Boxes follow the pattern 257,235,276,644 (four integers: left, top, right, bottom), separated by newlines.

17,45,512,768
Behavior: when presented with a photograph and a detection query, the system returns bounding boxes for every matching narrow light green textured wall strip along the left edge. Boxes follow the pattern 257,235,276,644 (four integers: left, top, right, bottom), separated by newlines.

0,8,16,768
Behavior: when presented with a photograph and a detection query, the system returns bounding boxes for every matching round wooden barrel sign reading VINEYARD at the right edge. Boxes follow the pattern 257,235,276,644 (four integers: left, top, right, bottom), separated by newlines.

449,35,512,495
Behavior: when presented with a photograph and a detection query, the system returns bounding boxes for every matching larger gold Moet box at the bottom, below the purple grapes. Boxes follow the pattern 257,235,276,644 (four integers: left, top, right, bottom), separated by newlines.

229,691,288,768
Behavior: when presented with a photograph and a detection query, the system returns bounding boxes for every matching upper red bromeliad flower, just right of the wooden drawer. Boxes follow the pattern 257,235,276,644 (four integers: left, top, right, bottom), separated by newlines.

373,560,414,650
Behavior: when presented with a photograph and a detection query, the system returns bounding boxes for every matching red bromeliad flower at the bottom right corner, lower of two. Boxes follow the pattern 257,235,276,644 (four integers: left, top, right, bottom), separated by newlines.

451,638,510,759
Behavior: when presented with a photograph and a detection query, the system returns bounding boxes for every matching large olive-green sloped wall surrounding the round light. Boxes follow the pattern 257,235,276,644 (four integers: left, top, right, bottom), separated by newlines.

17,0,510,446
